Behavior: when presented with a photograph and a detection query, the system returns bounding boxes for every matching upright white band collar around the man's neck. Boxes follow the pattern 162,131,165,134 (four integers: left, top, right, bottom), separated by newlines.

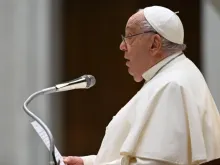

142,52,182,82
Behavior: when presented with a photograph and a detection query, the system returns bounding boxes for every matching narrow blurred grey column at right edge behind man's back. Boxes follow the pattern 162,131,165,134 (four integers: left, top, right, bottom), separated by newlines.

201,0,220,110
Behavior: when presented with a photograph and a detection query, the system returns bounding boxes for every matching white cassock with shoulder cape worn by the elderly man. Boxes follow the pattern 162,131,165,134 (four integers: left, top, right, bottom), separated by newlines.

82,52,220,165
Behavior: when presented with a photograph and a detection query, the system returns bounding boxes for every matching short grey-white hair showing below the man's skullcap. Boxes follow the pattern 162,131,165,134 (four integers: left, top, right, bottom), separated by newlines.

138,9,186,55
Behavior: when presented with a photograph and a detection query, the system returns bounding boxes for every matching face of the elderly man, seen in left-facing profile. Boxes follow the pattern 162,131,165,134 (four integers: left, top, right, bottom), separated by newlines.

120,12,160,82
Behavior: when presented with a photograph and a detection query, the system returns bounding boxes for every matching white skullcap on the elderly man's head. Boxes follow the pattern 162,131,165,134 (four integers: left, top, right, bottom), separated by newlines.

144,6,184,44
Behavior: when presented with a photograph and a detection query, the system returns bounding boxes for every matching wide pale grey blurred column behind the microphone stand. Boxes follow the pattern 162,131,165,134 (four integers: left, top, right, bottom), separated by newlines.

0,0,61,165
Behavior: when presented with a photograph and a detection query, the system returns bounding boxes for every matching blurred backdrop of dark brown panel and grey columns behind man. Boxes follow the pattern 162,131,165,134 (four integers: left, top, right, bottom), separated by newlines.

0,0,220,165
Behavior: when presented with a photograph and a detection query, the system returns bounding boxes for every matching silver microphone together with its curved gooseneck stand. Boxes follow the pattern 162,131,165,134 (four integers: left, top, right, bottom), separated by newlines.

23,75,96,165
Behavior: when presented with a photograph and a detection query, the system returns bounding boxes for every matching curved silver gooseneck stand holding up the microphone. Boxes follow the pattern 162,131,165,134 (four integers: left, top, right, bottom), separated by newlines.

23,87,58,165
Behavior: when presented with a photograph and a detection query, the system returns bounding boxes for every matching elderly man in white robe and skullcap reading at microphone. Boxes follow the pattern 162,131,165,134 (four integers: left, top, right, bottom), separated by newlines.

64,6,220,165
